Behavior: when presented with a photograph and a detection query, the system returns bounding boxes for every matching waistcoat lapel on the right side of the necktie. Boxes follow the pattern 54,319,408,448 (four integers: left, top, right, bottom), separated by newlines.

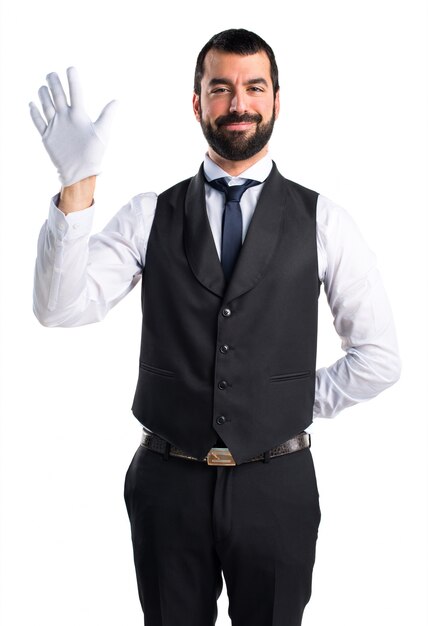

224,163,288,302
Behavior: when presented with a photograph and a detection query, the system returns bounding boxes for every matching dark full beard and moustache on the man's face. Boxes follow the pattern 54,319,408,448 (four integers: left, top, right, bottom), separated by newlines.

200,109,275,161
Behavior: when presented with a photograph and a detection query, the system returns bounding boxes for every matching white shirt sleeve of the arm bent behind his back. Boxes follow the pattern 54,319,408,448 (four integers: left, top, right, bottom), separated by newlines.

314,195,400,417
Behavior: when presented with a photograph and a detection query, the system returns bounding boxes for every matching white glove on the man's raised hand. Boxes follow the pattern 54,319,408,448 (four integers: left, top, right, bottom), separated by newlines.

30,67,117,187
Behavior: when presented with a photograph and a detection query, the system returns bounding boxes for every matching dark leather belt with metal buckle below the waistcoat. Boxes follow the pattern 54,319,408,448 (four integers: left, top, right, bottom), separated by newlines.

140,429,311,466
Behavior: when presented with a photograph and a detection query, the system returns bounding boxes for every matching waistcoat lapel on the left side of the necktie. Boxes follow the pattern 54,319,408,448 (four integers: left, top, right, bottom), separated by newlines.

184,165,226,297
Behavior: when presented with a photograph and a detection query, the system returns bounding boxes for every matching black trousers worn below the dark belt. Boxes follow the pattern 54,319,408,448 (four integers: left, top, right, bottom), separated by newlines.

125,438,321,626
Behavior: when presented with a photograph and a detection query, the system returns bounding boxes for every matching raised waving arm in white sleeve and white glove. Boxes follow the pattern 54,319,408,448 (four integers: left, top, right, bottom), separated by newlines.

30,67,149,326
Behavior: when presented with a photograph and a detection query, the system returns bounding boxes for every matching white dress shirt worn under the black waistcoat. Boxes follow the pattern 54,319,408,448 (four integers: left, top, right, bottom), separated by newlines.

34,155,400,417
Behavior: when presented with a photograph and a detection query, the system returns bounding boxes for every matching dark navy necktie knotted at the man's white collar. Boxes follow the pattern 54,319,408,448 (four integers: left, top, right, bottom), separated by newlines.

207,178,260,282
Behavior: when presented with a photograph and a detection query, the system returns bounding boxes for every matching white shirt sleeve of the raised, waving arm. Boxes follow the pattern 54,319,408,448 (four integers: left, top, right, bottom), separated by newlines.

33,193,157,327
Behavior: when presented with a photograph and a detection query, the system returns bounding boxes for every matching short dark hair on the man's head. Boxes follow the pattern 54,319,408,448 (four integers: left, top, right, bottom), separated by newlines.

193,28,279,96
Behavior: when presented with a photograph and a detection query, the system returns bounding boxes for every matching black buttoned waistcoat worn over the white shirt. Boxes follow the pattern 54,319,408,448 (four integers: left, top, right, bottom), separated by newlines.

132,164,319,464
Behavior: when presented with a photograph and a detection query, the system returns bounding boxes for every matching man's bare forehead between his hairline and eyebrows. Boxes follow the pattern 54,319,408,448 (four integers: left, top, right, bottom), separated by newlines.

202,50,272,84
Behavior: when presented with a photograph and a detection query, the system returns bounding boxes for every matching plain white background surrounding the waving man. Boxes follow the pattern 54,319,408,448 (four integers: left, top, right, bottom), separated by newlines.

0,0,428,626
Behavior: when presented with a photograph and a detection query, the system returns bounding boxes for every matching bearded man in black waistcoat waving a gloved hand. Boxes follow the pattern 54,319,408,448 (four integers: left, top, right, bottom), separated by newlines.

31,29,399,626
